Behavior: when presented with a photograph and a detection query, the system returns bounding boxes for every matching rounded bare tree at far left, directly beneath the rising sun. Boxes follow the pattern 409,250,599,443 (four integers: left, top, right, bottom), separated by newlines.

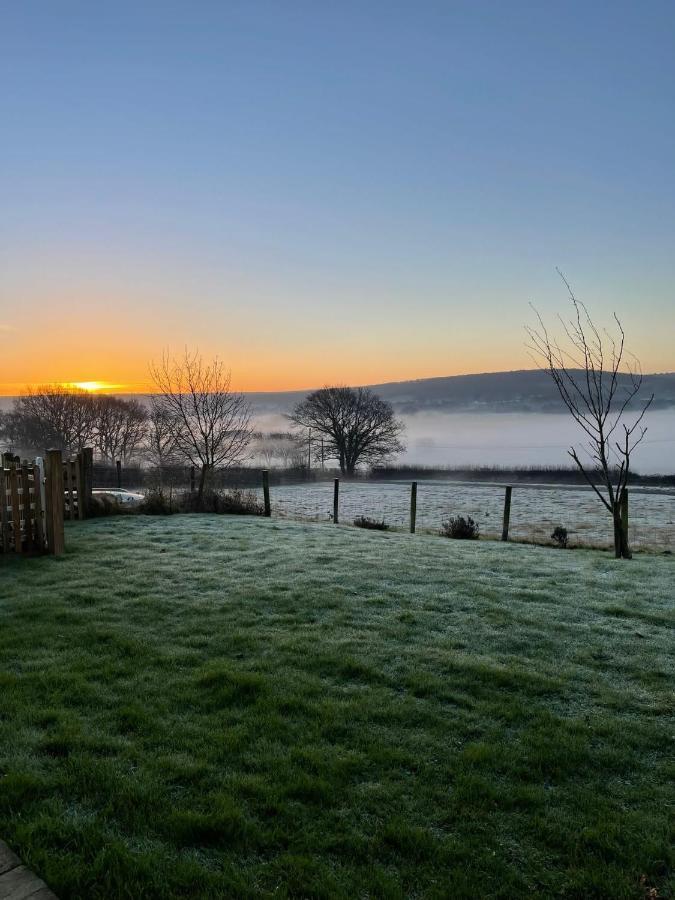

5,384,96,452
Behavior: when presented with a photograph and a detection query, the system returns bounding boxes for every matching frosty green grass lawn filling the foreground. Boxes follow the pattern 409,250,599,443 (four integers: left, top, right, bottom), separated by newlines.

0,516,675,900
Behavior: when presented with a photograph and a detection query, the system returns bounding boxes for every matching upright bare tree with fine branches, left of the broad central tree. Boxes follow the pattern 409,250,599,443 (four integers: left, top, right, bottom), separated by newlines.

150,349,252,504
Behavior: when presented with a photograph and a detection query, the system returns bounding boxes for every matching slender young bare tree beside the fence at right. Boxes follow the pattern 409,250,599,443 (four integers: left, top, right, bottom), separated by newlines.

526,270,654,559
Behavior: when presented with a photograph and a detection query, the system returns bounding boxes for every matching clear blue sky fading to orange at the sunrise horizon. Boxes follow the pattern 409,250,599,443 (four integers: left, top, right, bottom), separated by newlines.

0,0,675,394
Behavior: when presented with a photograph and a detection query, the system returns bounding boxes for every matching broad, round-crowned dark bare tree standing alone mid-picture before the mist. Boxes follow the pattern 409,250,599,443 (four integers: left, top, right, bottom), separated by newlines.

289,387,405,475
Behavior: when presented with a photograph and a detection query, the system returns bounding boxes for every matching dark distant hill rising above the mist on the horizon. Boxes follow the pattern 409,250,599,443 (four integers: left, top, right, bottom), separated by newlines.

248,369,675,415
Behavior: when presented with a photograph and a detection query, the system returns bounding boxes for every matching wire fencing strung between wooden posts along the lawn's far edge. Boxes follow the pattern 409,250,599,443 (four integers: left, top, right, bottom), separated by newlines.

94,466,675,553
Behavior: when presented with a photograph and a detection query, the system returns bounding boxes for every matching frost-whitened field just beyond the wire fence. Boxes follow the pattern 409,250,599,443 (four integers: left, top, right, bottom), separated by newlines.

250,480,675,553
